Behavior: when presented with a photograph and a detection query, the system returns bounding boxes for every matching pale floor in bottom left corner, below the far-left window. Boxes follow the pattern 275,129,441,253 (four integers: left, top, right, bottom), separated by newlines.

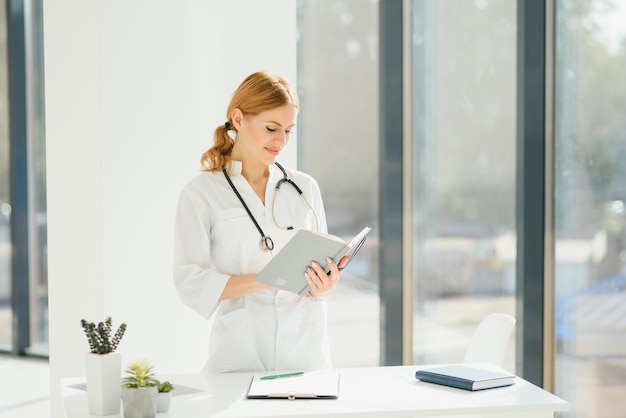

0,355,50,418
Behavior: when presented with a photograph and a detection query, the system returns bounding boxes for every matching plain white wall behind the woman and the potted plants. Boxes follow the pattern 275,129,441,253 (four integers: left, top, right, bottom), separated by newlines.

44,0,296,417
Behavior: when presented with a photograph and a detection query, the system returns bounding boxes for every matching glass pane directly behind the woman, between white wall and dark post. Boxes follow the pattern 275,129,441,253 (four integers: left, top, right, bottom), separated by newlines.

298,0,380,367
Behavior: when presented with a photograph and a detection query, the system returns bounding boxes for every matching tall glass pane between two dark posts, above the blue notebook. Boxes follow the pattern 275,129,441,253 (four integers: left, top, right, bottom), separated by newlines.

412,0,517,371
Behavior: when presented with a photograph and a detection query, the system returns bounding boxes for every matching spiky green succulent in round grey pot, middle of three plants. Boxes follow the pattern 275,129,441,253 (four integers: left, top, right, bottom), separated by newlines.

122,359,159,418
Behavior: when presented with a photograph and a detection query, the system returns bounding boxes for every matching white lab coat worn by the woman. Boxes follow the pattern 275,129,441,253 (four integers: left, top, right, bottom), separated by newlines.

174,161,331,372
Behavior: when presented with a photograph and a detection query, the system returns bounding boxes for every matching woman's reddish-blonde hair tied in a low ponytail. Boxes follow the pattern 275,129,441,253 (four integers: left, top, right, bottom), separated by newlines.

200,71,300,171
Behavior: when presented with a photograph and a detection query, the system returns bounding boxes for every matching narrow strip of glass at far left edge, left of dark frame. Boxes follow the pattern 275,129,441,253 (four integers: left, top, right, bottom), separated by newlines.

0,0,13,350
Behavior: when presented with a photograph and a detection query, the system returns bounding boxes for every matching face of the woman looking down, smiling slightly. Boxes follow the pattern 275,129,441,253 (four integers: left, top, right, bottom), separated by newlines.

231,104,298,165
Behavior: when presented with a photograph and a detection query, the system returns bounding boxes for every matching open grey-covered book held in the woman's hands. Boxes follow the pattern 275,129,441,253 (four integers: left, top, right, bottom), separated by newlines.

254,227,372,296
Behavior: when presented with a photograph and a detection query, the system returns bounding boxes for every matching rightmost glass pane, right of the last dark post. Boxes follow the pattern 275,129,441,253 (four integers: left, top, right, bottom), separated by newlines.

555,0,626,417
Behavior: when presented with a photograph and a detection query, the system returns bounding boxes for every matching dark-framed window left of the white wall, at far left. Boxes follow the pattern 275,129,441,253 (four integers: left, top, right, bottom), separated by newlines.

0,0,48,356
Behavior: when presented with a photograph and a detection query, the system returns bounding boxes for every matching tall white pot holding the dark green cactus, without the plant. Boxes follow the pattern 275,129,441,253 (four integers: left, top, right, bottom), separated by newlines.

85,353,122,415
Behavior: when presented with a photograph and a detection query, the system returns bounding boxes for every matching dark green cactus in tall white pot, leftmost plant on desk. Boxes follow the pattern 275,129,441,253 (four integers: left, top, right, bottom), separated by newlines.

80,317,126,415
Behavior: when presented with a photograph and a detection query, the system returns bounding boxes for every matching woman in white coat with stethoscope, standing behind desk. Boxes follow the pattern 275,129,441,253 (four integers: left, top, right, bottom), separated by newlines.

174,71,348,372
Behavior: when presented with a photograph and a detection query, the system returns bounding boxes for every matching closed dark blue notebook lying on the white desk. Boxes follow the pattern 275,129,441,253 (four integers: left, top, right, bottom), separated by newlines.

415,364,515,391
